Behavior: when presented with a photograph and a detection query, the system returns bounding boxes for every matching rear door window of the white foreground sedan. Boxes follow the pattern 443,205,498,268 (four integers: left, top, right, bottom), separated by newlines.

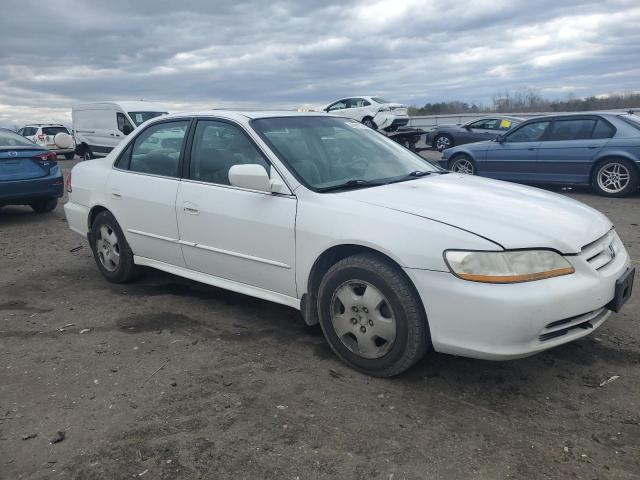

126,120,189,177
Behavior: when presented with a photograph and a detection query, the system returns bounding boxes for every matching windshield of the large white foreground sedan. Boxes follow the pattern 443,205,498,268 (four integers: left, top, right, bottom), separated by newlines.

251,117,441,191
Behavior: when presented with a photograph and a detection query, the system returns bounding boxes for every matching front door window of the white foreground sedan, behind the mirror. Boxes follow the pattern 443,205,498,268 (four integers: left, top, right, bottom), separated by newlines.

189,120,269,185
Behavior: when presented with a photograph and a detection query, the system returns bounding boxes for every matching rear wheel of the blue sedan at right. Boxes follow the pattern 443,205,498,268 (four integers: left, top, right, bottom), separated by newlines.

591,158,639,197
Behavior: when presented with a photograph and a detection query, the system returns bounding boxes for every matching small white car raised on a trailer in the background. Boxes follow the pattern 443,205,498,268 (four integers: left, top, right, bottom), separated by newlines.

323,96,409,132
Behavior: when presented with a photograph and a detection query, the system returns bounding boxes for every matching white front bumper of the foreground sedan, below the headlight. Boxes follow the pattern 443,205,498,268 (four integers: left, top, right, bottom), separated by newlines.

405,236,630,360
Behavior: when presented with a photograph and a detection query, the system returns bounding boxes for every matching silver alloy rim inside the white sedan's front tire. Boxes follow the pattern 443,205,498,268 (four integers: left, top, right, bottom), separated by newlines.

331,280,396,359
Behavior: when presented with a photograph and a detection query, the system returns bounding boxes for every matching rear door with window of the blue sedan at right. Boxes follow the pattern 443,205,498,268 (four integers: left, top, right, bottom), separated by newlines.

538,115,615,183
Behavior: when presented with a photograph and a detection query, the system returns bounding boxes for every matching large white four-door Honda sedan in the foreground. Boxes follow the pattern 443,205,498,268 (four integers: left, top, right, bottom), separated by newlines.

65,110,634,376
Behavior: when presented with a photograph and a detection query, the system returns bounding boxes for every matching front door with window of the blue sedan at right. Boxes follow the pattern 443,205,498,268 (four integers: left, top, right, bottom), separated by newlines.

477,119,551,182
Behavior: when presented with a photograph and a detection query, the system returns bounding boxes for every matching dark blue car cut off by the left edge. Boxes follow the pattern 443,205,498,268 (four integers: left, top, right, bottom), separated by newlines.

0,128,64,213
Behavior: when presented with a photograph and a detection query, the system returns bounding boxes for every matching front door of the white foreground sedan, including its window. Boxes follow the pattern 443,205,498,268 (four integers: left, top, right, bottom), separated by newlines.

176,120,297,297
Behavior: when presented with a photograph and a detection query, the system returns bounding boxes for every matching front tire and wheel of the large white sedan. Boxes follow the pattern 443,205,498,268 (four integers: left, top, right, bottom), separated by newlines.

318,253,431,377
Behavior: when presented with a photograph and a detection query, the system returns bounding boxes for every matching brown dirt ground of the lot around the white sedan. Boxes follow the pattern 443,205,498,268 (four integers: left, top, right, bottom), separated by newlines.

0,156,640,480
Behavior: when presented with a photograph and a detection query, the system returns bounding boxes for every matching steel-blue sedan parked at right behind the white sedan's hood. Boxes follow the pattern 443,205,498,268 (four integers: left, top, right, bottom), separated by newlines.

440,112,640,197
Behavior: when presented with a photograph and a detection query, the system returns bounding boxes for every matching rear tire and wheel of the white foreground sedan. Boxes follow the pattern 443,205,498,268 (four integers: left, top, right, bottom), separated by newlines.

89,210,140,283
